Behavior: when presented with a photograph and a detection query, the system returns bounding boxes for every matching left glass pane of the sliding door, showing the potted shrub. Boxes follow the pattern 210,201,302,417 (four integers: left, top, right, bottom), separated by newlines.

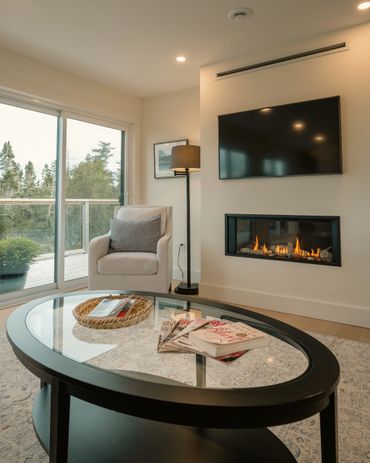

0,104,57,298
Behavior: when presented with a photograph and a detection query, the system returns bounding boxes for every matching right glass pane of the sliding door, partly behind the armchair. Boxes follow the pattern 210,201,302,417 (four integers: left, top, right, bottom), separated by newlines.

64,118,124,281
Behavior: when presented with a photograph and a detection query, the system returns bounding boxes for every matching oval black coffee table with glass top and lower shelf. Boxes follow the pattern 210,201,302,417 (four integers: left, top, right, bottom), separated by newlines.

7,291,339,463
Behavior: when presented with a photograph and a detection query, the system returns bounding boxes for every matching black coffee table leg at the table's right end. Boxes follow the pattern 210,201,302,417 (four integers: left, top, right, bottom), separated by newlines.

320,391,338,463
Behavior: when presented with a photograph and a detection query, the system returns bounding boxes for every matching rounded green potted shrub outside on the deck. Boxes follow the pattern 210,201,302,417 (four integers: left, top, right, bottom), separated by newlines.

0,238,41,275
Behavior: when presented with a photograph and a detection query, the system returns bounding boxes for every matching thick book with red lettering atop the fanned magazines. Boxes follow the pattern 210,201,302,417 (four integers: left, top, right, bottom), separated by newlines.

189,322,267,357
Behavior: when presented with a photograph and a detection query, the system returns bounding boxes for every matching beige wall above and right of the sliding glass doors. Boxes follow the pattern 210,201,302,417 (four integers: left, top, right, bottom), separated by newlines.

0,48,141,202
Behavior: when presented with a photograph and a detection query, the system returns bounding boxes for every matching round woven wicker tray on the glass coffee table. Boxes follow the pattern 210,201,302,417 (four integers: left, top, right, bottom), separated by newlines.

73,294,153,329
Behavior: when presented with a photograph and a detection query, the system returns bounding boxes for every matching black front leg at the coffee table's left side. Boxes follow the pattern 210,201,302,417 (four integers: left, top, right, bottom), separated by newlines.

50,378,70,463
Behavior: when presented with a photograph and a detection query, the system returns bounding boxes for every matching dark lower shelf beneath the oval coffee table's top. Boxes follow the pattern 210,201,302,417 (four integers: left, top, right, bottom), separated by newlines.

33,385,297,463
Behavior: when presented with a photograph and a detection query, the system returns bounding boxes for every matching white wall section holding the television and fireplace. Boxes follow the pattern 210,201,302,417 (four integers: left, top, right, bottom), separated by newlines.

201,23,370,327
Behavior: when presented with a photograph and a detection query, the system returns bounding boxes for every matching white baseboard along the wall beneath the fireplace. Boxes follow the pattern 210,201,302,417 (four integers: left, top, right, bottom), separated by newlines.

199,283,370,328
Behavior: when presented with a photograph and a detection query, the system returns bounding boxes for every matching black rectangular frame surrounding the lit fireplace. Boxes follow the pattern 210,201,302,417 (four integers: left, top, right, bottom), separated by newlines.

225,214,342,267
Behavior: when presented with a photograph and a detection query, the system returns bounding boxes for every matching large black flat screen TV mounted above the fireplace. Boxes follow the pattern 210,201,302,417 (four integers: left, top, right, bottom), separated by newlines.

218,96,342,179
